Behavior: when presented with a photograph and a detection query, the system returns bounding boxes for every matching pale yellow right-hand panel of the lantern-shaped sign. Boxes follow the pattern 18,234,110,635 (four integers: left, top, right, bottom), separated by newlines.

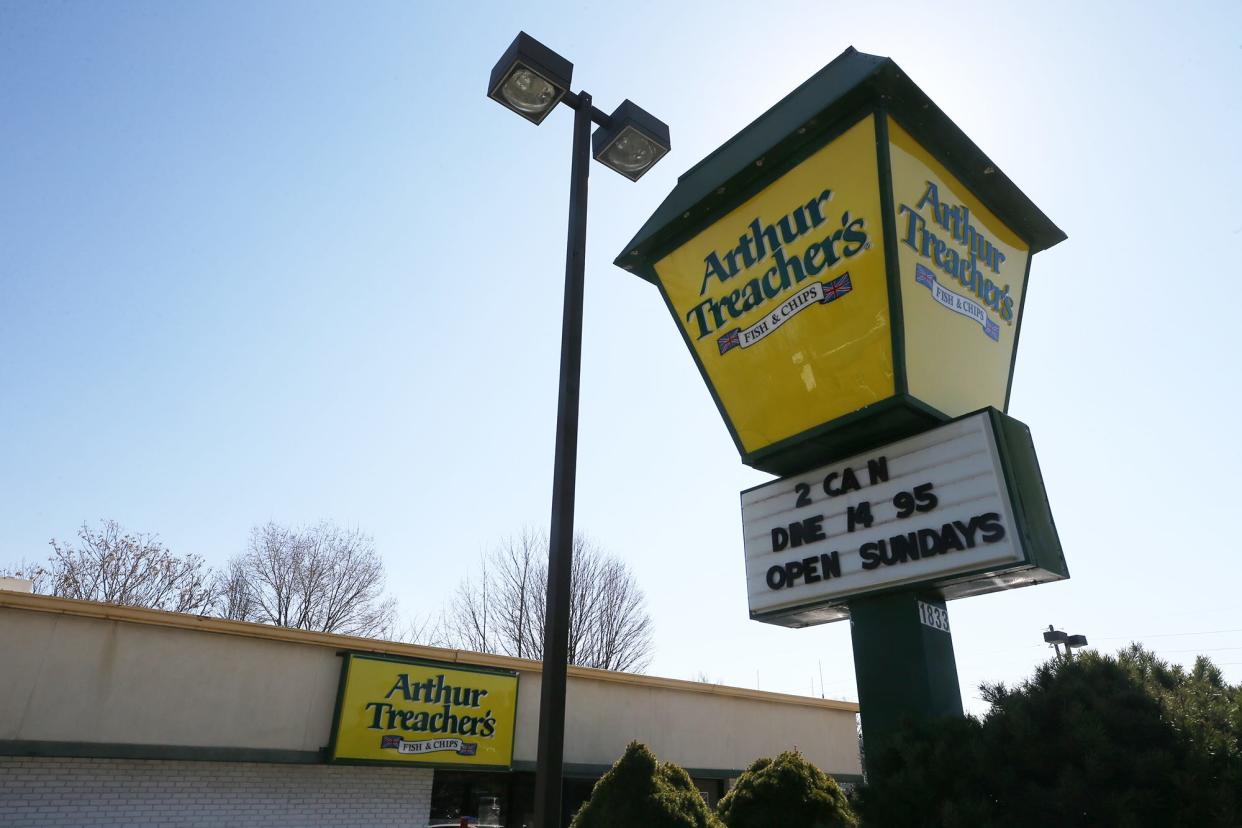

888,119,1030,417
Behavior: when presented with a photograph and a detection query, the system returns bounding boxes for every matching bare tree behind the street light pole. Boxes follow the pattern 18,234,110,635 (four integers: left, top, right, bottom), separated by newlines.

443,530,652,672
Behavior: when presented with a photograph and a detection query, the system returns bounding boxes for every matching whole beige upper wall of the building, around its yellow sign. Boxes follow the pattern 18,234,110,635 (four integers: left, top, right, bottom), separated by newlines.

0,592,859,775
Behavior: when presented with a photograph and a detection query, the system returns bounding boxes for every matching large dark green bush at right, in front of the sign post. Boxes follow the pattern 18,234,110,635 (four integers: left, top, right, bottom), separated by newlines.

856,647,1242,828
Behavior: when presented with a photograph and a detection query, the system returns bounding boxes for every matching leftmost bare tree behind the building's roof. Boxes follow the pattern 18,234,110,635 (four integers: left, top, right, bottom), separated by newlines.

1,520,215,613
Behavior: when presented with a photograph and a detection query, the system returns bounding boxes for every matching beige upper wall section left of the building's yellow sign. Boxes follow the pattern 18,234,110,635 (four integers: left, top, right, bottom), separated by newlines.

0,608,340,751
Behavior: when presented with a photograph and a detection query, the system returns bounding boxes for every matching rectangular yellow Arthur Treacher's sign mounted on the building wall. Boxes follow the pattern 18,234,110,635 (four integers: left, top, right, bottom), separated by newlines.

329,653,518,768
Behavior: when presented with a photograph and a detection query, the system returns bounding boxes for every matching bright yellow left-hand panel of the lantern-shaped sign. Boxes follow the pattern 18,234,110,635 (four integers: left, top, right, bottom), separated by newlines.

655,115,894,452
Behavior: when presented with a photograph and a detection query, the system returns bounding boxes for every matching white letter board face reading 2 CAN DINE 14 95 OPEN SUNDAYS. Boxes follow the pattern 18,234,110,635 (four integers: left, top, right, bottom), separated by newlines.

741,412,1028,626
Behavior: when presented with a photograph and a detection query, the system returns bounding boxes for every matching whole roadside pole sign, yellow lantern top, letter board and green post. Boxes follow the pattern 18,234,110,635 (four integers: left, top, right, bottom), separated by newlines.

616,48,1069,779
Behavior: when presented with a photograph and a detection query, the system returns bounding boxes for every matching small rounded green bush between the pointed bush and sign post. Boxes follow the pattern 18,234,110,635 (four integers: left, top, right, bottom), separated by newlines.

717,750,858,828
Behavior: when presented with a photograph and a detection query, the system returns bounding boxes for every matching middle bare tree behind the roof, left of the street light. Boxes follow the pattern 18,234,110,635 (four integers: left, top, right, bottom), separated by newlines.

220,523,396,637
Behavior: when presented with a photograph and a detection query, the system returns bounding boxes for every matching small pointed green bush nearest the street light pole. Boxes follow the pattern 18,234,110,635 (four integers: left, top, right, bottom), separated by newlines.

570,742,720,828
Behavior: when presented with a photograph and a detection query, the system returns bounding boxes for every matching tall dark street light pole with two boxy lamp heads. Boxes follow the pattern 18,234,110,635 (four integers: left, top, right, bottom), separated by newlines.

487,32,672,828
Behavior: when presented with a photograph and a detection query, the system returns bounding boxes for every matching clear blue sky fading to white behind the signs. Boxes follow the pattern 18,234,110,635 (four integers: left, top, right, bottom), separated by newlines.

0,0,1242,709
